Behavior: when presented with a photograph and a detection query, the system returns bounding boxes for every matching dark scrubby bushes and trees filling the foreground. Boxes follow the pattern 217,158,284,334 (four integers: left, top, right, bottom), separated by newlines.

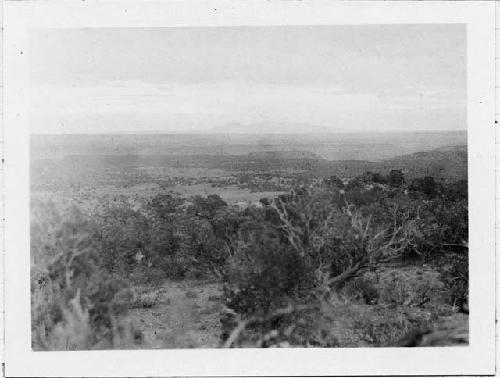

31,170,468,350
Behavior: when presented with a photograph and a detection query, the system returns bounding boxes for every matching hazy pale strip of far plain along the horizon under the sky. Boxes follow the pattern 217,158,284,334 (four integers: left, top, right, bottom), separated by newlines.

30,131,467,162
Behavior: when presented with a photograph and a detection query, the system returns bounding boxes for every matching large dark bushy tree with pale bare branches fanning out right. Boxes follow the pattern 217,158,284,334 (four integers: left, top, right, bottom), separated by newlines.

226,188,405,318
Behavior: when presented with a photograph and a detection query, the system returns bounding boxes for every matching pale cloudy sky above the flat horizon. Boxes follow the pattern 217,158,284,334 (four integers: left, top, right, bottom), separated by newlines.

28,24,466,134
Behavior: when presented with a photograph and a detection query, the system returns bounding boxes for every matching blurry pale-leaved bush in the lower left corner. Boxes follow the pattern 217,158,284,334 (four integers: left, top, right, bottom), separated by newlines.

31,201,142,350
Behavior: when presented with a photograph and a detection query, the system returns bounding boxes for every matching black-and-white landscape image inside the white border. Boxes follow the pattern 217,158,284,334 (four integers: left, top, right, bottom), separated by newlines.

2,2,494,376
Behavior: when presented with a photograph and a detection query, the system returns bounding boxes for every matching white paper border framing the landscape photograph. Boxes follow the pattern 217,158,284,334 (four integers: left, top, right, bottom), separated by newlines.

4,0,495,377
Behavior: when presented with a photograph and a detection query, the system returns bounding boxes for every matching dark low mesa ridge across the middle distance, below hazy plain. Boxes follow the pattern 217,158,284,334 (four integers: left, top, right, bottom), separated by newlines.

32,145,467,181
